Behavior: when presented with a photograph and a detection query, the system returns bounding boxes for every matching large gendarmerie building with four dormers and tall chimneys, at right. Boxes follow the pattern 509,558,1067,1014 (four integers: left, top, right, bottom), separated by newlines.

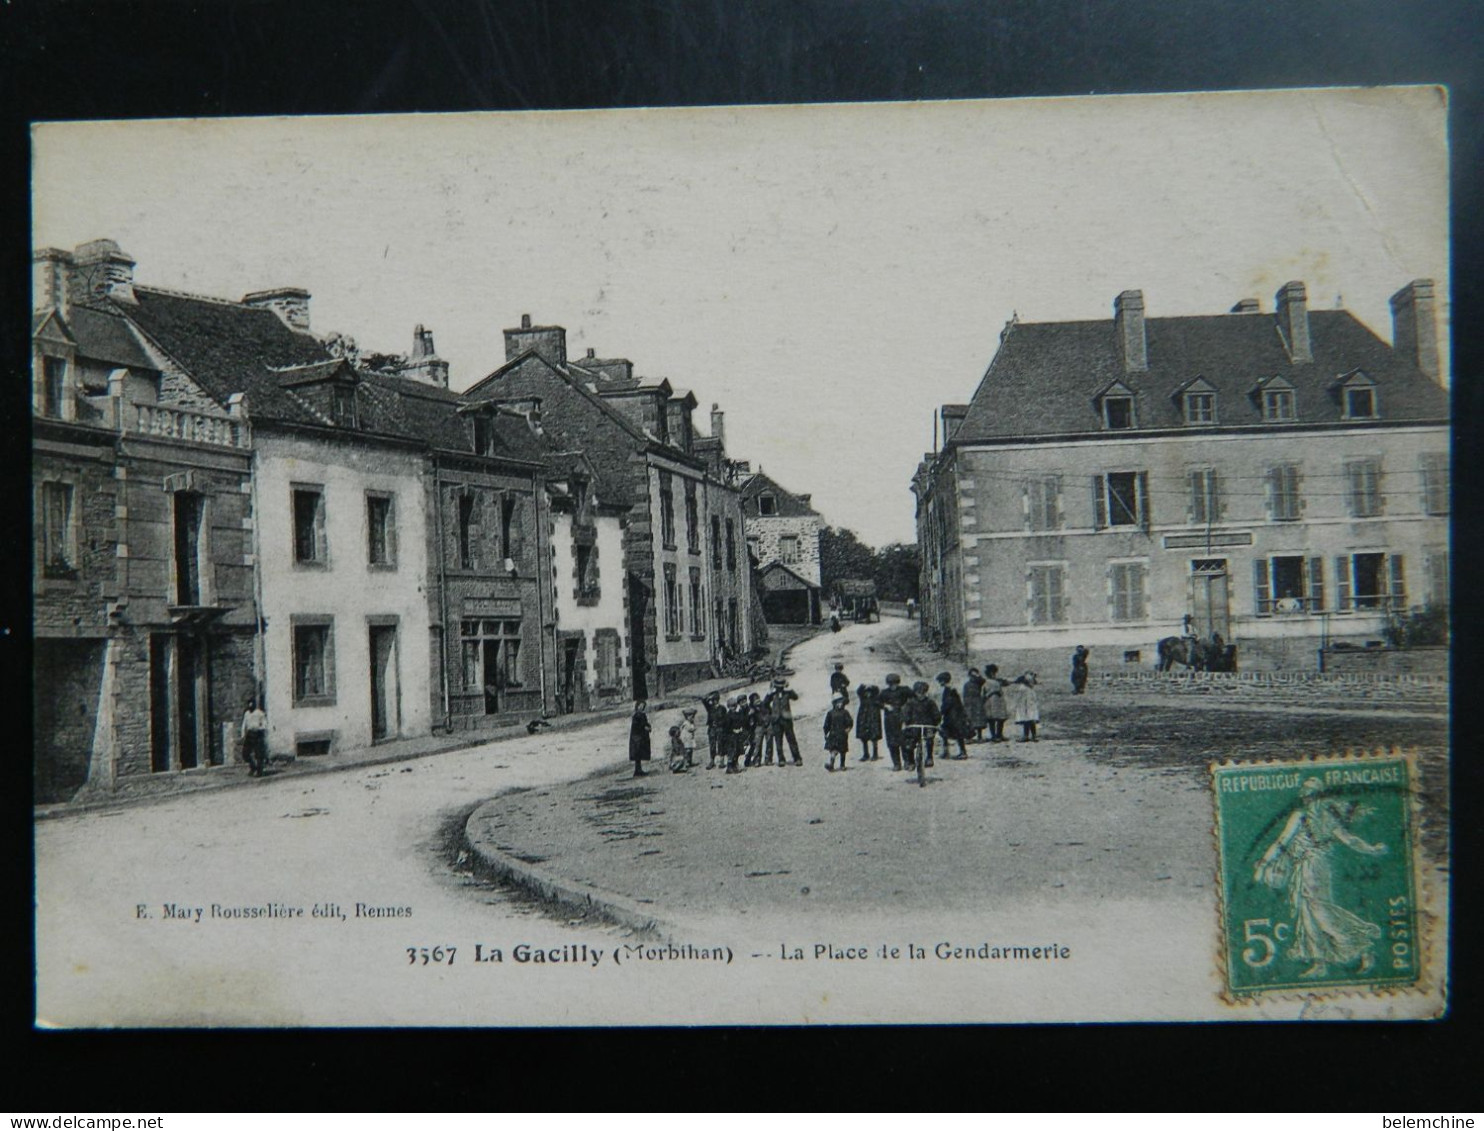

913,281,1448,668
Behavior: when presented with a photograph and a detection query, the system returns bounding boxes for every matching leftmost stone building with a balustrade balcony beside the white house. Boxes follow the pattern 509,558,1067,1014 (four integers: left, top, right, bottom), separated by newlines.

31,240,257,801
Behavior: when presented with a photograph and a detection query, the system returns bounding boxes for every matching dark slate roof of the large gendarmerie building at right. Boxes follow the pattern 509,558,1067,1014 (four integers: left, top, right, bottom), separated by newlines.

951,310,1448,445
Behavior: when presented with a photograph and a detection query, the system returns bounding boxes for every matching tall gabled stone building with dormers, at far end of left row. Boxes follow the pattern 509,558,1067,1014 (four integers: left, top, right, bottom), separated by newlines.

464,316,754,698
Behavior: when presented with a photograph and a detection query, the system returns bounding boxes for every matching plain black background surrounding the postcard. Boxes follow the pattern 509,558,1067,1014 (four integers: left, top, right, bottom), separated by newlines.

0,0,1484,1125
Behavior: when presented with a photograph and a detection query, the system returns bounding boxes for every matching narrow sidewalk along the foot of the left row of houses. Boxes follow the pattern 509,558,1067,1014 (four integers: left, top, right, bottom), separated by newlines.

33,664,777,821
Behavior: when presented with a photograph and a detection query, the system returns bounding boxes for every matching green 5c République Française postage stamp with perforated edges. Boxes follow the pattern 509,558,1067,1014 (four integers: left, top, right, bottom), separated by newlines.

1211,754,1423,999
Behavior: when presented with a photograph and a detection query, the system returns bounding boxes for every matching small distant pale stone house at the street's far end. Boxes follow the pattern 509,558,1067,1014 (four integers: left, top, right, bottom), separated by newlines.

742,469,824,623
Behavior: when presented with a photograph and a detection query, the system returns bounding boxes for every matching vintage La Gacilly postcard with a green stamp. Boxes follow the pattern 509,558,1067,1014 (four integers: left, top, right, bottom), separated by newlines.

31,86,1450,1027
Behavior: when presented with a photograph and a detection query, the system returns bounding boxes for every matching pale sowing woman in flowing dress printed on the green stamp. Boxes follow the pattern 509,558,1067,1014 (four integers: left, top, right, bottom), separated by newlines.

1252,778,1388,978
